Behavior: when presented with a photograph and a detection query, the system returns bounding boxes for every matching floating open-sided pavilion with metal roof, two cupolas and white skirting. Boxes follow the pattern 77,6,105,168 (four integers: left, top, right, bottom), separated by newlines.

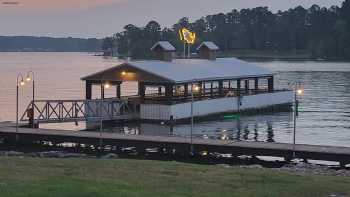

82,41,293,121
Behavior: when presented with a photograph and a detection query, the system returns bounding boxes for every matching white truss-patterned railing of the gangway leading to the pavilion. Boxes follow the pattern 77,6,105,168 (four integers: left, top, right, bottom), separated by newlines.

20,99,132,123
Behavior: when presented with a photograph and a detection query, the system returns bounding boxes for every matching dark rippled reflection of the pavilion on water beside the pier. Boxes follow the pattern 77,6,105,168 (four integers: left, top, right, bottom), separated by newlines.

105,112,292,142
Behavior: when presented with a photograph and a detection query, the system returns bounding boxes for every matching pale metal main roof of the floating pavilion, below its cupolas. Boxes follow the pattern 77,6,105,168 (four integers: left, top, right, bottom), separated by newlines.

82,58,273,83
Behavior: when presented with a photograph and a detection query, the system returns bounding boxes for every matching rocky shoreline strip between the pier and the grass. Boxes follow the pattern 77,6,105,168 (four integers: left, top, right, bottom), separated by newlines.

0,150,350,177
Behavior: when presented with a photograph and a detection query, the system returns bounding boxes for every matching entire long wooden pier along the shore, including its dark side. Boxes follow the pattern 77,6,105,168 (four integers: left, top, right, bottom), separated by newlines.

0,125,350,166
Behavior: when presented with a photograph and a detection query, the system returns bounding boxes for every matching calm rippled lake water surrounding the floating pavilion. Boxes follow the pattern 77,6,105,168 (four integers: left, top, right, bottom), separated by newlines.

0,53,350,147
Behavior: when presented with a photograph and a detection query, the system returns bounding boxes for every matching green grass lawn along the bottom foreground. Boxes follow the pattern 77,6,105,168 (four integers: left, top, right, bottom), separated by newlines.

0,157,350,197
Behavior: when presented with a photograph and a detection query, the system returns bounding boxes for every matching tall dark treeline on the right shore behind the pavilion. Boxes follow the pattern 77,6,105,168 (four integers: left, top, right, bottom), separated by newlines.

102,0,350,59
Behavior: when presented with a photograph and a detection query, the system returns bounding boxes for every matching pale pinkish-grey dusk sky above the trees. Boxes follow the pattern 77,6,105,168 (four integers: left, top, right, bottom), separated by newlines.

0,0,343,38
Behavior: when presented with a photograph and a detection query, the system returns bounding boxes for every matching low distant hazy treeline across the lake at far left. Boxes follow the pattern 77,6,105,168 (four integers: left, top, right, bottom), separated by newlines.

0,36,102,52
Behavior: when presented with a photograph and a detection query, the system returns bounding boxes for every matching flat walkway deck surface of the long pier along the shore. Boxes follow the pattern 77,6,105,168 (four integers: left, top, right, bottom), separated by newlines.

0,125,350,163
